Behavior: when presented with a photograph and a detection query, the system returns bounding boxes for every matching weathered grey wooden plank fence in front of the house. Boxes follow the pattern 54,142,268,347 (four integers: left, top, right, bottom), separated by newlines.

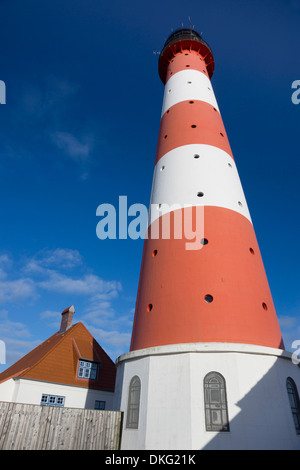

0,402,122,450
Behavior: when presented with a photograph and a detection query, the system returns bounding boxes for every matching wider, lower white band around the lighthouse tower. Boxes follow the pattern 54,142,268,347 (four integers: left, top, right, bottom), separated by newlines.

150,144,251,225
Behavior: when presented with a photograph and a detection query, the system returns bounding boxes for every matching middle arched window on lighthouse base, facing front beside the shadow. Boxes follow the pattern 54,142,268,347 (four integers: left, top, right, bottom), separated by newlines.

204,372,229,431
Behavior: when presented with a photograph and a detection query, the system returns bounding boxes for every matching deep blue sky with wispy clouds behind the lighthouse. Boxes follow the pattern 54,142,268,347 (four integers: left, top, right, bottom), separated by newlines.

0,0,300,371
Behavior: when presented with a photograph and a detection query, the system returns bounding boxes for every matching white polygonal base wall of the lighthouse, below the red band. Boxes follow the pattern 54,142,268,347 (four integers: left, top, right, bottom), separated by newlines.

116,343,300,450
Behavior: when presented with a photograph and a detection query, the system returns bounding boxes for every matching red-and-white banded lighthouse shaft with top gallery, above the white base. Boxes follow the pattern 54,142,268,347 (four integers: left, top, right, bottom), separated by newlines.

131,31,283,351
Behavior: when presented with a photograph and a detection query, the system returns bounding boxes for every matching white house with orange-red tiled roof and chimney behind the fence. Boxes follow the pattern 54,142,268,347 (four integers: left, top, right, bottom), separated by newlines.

0,306,116,410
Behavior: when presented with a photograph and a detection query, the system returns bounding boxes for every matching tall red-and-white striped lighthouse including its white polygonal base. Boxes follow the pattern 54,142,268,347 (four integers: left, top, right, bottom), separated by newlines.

115,29,300,450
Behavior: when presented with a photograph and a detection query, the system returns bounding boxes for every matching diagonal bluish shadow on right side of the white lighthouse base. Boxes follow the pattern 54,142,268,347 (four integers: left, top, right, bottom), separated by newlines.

203,358,300,450
